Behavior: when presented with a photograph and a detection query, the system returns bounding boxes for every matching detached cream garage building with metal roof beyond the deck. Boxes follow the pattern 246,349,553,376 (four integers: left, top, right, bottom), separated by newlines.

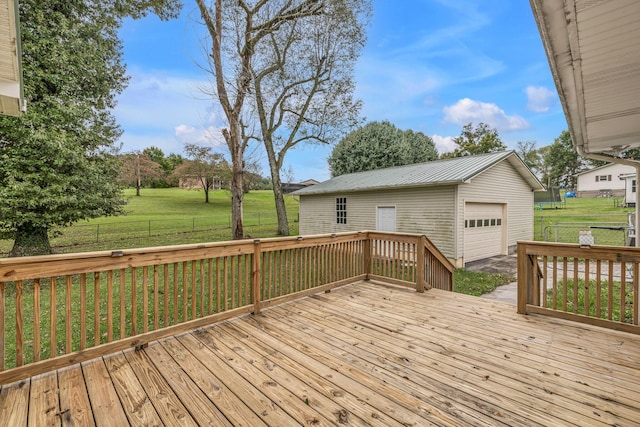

294,151,544,266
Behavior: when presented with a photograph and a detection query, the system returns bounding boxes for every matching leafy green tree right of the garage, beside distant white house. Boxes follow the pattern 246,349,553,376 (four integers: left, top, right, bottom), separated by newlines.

545,130,585,188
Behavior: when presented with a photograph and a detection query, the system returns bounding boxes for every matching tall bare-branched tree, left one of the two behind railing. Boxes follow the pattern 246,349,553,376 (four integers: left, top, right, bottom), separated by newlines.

196,0,324,239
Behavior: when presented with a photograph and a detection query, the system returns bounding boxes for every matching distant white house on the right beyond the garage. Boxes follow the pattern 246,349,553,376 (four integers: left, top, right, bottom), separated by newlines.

576,163,635,197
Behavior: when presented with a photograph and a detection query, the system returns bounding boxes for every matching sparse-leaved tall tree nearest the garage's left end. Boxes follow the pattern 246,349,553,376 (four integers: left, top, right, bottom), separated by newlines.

250,0,371,235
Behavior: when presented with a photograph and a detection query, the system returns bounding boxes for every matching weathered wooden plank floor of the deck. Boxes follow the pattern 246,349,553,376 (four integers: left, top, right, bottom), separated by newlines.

0,283,640,426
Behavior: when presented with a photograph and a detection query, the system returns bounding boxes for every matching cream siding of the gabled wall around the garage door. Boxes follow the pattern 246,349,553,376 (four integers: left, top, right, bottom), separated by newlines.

457,162,533,257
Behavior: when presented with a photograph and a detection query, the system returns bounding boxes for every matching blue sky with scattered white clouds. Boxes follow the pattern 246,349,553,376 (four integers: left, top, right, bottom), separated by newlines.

115,0,567,181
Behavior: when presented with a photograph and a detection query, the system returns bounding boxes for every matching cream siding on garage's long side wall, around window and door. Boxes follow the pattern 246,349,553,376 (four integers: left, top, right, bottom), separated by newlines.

300,186,455,258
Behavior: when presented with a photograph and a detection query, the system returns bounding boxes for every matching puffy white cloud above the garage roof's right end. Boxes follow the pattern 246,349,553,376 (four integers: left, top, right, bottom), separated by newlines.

443,98,529,131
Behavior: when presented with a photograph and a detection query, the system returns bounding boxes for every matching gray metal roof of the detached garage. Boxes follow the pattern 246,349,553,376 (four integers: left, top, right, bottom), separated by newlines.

294,151,544,195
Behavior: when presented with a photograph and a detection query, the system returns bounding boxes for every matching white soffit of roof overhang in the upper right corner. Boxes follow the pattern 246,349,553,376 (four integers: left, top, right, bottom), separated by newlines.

530,0,640,154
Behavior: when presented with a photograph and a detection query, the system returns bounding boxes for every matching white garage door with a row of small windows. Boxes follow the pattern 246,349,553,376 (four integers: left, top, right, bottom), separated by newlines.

464,203,506,262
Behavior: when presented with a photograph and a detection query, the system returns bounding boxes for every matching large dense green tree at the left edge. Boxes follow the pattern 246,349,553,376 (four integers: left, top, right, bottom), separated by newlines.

0,0,179,256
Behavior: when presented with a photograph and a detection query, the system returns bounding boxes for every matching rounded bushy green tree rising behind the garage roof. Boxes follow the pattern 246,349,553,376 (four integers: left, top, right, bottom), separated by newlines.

328,121,438,176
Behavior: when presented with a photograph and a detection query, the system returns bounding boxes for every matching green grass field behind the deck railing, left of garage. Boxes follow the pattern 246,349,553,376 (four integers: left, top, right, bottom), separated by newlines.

0,188,298,256
